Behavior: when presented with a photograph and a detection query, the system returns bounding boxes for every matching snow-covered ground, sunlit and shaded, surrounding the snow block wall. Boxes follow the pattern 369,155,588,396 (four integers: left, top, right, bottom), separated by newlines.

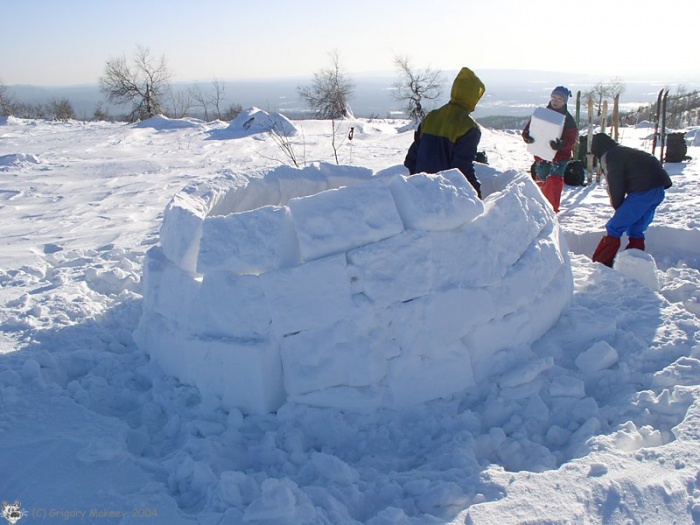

0,111,700,525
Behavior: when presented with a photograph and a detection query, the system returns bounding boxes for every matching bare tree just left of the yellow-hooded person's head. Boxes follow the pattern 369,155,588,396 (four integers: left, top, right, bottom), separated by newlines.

393,56,444,123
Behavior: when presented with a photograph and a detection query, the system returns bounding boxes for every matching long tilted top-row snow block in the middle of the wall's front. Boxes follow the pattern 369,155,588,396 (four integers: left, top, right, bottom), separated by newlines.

289,181,403,261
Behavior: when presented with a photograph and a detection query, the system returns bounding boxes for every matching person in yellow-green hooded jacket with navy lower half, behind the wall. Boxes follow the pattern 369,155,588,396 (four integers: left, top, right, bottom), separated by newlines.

404,67,486,198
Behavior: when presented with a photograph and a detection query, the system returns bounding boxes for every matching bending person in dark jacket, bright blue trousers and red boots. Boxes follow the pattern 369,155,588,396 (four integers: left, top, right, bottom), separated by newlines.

591,133,672,267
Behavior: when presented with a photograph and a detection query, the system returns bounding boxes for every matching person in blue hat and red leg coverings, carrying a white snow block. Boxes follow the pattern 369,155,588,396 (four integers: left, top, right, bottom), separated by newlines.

522,86,578,213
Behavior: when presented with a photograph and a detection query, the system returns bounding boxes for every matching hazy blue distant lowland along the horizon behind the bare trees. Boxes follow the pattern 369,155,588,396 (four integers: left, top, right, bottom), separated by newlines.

7,69,700,123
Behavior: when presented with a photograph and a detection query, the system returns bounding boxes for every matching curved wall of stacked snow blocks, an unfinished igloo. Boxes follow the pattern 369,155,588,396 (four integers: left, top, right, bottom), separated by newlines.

134,164,573,413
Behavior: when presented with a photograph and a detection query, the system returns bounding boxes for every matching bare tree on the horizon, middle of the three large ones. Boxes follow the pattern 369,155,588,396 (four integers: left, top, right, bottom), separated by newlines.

298,51,355,120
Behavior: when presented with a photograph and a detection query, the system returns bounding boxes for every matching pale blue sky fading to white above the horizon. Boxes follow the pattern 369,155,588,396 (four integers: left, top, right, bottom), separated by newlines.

0,0,700,86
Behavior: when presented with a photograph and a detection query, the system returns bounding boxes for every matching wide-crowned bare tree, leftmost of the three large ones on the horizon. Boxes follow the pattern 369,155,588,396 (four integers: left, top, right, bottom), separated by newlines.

100,46,170,122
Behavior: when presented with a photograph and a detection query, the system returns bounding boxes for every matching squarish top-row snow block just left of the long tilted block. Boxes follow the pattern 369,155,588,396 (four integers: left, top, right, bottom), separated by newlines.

197,206,300,275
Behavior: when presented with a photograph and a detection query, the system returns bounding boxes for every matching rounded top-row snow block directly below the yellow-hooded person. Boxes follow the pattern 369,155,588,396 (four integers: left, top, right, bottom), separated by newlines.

389,169,484,231
